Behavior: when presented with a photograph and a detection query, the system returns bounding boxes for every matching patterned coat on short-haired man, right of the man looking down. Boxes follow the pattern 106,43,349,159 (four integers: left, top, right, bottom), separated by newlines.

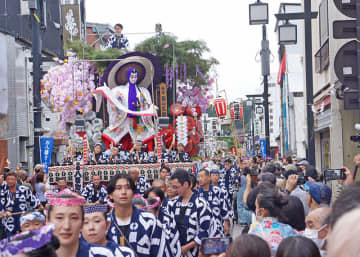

198,184,232,237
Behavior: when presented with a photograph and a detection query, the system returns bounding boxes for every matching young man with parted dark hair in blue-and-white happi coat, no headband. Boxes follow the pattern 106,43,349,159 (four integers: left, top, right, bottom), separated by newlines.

107,174,173,257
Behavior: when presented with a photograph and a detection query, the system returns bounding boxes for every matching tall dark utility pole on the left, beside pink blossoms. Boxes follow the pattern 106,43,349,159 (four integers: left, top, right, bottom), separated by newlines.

29,0,42,164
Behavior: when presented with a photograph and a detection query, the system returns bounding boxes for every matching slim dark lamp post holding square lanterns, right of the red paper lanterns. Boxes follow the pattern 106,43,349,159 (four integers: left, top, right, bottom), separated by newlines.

260,24,270,156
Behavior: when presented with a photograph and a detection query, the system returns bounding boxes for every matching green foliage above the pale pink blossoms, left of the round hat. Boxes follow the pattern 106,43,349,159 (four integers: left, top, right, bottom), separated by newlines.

65,40,125,72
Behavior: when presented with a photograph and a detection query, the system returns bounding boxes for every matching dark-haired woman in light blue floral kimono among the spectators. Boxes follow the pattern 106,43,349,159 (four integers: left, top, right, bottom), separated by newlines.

249,189,297,253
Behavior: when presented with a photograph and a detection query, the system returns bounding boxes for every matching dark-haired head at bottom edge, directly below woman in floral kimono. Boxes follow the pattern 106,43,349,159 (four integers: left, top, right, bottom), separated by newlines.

276,236,320,257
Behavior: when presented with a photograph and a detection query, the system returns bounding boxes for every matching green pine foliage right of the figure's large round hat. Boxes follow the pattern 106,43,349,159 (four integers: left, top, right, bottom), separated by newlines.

135,35,219,85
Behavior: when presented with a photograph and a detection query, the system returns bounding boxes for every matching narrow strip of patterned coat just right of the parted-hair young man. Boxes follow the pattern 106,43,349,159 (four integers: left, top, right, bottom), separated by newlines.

158,207,181,257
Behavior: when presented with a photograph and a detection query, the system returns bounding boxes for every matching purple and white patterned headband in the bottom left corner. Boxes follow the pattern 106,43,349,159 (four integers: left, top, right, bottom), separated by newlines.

0,223,54,257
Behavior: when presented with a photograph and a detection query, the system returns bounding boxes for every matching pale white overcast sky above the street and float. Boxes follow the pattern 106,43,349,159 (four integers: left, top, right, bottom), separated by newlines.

86,0,301,100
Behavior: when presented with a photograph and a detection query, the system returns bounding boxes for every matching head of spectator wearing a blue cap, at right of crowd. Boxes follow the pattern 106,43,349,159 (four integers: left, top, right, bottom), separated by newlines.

305,181,331,210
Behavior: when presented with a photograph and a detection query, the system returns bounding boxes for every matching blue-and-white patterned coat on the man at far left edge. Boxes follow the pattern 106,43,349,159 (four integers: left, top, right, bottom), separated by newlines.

3,185,40,237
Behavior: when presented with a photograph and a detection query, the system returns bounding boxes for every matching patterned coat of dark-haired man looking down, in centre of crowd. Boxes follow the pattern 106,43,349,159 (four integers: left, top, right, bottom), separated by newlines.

168,194,212,257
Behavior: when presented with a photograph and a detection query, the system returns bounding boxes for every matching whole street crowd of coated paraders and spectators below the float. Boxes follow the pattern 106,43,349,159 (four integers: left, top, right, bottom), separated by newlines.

0,152,360,257
